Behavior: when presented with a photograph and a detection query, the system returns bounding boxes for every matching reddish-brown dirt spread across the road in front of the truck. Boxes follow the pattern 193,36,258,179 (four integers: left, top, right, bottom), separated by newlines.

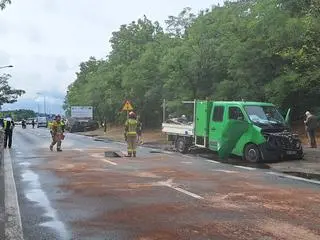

33,149,320,240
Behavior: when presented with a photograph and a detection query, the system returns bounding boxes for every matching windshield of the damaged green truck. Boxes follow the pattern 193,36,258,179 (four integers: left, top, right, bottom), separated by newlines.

245,106,285,125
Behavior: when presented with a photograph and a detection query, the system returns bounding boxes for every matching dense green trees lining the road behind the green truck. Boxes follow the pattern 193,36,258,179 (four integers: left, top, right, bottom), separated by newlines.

64,0,320,126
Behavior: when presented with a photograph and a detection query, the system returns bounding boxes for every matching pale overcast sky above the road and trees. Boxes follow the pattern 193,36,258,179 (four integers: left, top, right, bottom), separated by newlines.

0,0,223,112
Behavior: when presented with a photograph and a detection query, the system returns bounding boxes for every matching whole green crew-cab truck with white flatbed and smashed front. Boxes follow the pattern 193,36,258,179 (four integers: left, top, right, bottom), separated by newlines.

162,100,303,162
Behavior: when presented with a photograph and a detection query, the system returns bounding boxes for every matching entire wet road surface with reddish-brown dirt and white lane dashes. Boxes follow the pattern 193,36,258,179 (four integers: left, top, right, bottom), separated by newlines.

5,126,320,240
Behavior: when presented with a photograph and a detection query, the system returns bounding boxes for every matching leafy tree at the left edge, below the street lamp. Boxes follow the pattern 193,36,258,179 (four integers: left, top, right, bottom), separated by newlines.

0,74,25,107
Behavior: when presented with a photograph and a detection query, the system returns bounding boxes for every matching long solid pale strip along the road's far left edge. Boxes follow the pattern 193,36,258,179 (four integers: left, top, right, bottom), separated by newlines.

4,151,23,240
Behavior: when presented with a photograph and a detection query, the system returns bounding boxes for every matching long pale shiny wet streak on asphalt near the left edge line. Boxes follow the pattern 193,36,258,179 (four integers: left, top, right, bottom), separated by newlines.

22,170,68,239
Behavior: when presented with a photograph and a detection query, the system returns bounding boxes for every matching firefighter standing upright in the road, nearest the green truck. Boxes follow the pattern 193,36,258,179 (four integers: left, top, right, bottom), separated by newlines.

124,112,138,157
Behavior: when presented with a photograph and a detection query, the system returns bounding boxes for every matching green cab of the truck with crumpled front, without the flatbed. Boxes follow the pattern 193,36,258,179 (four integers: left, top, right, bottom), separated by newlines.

208,101,303,162
